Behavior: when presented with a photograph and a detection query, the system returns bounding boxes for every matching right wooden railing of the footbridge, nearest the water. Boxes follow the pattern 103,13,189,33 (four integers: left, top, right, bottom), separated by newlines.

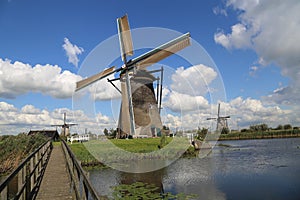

62,140,100,200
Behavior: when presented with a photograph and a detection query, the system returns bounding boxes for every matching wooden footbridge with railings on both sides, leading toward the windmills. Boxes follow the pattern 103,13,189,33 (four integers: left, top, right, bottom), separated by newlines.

0,140,100,200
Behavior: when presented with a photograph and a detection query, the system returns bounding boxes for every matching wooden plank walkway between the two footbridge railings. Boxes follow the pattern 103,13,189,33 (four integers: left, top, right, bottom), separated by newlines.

36,146,73,200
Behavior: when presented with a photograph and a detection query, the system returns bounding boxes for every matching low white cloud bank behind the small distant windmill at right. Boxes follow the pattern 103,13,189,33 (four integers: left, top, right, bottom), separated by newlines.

162,97,292,130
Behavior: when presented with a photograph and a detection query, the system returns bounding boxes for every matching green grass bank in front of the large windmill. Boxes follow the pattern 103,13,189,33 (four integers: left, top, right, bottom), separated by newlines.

69,137,196,167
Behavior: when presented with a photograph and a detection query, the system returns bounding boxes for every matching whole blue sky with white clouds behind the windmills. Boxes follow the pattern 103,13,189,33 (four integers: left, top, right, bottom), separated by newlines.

0,0,300,135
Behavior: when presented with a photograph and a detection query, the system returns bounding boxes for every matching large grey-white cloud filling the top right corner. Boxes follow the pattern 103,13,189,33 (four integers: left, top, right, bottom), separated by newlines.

214,0,300,105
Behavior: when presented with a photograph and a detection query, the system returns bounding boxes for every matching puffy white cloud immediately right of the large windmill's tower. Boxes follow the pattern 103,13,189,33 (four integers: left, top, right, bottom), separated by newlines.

157,64,217,113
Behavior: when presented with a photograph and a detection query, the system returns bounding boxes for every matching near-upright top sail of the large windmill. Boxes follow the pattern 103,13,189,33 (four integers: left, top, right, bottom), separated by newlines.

117,15,133,62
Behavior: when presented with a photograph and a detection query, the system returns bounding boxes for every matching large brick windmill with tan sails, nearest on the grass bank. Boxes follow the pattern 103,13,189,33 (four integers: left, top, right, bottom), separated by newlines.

76,15,190,136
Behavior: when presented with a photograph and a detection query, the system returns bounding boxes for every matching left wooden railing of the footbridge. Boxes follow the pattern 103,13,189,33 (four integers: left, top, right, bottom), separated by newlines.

0,140,52,200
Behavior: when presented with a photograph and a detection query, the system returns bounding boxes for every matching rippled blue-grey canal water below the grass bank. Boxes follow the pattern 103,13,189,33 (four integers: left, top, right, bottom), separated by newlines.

90,138,300,200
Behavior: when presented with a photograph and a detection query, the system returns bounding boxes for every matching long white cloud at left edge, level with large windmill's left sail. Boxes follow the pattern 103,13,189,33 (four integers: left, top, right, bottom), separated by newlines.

0,58,81,98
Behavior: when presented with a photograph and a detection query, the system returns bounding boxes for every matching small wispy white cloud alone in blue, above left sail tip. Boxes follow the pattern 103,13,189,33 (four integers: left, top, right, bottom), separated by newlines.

62,38,84,67
